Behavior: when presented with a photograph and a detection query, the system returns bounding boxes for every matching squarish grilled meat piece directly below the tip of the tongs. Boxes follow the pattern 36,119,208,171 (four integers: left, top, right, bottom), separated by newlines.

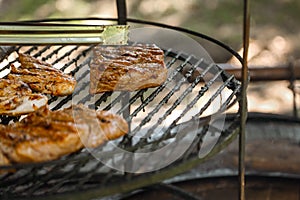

90,44,168,94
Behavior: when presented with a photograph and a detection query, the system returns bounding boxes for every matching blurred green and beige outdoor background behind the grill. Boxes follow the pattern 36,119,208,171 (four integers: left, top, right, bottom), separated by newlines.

0,0,300,114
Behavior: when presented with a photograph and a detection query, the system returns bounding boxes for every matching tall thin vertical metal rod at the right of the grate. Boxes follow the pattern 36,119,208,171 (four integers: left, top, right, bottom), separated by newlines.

239,0,250,200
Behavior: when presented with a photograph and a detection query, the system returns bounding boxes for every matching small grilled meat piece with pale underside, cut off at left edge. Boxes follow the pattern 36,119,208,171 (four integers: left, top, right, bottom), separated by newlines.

0,79,48,115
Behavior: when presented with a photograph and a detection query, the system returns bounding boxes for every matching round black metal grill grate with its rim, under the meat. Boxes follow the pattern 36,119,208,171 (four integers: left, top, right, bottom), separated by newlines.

0,0,248,199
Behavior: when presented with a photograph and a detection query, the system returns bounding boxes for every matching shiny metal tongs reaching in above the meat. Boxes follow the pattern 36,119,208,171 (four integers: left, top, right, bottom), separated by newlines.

0,22,128,45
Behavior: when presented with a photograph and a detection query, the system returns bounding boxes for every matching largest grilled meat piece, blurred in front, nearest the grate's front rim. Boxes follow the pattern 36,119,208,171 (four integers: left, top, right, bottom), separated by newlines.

0,105,128,164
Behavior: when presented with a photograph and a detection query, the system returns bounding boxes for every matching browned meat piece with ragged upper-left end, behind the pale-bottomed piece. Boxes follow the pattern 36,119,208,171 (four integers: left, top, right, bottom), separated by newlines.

8,53,76,96
